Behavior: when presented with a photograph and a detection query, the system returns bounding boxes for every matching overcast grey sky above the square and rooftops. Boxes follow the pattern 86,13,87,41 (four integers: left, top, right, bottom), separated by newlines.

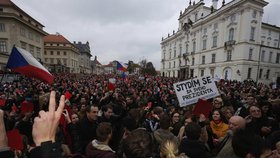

12,0,280,70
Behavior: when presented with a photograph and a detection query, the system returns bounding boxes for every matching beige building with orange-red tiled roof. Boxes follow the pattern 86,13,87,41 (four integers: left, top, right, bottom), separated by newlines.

44,33,80,73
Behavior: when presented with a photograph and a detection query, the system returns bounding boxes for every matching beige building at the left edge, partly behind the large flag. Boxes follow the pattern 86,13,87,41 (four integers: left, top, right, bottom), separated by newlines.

0,0,47,70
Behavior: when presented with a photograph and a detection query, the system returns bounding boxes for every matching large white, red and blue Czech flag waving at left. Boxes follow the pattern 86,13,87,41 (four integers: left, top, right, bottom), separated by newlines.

7,46,54,84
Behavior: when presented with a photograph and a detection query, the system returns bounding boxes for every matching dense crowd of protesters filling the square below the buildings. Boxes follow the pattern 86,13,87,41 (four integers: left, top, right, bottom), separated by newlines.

0,74,280,158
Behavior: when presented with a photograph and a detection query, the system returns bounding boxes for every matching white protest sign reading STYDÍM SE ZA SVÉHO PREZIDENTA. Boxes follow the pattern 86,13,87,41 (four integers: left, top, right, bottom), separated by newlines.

173,76,220,107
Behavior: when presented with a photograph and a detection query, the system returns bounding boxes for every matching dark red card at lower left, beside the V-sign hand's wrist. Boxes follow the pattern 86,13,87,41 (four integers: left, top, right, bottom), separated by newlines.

7,129,23,150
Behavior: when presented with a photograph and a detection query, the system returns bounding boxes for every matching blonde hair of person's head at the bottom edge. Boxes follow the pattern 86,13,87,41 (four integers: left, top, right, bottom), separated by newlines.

160,139,179,158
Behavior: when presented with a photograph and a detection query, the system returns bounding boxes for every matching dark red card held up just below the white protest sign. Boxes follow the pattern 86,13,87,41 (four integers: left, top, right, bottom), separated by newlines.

193,99,213,118
